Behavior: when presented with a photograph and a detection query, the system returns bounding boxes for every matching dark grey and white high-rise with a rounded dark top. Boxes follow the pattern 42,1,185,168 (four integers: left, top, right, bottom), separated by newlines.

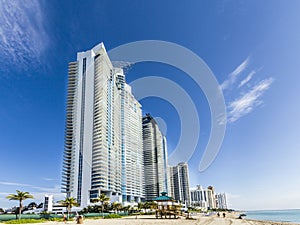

143,114,168,201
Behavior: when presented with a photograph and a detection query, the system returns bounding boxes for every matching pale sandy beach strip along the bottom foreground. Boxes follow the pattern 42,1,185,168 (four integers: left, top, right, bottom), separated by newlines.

2,214,300,225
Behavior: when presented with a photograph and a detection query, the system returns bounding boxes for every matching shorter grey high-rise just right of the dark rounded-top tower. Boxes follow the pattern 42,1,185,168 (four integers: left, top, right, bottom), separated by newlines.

169,163,191,206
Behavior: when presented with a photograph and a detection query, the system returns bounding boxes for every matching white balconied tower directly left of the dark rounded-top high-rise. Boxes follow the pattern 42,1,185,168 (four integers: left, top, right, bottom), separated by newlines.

121,78,145,202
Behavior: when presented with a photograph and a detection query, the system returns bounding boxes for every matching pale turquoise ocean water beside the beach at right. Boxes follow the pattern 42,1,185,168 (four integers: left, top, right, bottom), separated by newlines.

245,209,300,223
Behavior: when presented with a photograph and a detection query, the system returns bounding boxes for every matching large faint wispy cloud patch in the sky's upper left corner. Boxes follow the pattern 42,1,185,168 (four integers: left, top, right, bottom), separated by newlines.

0,0,48,70
